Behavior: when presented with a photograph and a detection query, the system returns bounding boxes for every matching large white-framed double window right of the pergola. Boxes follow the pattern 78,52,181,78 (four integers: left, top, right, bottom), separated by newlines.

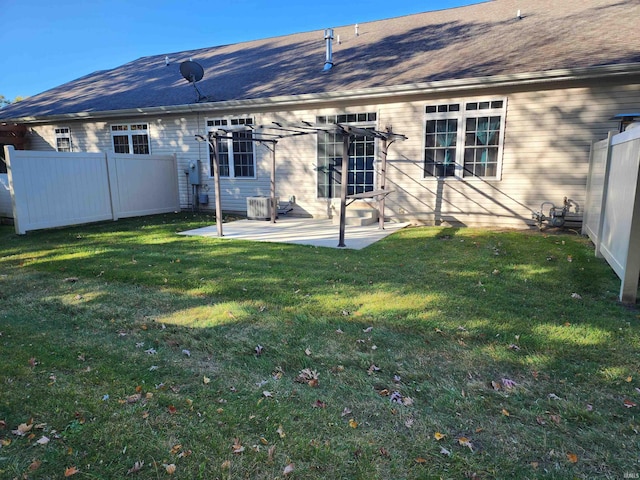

424,99,506,178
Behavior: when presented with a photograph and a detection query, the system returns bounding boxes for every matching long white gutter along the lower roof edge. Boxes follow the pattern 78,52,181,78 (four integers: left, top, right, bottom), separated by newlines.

5,63,640,123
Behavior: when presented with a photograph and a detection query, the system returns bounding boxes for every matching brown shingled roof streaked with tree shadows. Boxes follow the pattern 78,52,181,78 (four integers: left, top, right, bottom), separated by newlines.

0,0,640,121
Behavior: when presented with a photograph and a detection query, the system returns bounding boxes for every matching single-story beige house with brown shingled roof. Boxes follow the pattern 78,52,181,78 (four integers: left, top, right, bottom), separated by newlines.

0,0,640,227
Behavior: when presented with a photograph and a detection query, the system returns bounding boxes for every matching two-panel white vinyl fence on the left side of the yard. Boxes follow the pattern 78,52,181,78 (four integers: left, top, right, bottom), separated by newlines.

0,146,180,234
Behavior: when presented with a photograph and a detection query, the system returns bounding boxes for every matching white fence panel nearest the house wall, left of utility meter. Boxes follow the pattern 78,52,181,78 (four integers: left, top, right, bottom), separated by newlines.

107,154,180,220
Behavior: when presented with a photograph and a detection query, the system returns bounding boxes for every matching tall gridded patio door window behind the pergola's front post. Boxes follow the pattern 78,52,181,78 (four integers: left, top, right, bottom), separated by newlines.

316,113,377,198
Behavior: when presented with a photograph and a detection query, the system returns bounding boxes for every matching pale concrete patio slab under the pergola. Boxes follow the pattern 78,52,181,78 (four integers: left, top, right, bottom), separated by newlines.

179,217,409,250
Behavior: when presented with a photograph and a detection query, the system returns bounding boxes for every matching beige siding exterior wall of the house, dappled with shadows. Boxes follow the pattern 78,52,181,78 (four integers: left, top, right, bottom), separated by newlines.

22,77,640,227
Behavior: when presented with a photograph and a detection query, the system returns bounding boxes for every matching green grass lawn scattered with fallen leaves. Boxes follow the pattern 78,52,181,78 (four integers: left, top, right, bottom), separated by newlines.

0,213,640,479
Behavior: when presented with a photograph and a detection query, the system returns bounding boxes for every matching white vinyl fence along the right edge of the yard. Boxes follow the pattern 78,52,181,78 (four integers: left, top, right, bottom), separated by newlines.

582,128,640,303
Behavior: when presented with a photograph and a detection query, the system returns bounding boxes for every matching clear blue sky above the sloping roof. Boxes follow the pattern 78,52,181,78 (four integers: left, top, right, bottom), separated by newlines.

0,0,480,100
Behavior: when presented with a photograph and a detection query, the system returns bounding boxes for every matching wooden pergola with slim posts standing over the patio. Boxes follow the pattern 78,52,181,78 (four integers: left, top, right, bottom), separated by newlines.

196,122,407,247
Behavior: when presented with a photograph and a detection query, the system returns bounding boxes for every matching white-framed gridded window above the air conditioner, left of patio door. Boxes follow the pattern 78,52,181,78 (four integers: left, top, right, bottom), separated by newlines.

207,118,256,178
